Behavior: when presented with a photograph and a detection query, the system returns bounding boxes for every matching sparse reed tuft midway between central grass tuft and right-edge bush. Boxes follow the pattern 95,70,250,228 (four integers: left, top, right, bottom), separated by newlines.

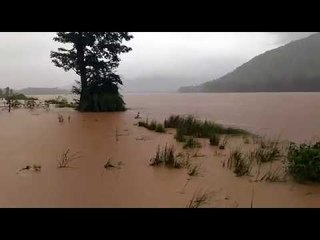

227,150,253,177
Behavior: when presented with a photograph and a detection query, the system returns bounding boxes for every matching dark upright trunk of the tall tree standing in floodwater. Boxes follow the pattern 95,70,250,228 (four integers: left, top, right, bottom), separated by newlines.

76,32,87,111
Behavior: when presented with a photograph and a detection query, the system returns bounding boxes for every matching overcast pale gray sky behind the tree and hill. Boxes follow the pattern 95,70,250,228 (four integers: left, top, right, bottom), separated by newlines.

0,32,312,91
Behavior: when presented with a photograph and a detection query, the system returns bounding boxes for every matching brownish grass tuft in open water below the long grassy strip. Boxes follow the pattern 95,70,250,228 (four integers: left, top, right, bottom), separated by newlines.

150,144,187,168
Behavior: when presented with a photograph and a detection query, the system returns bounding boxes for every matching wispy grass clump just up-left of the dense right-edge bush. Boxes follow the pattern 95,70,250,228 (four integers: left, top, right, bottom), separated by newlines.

255,140,282,163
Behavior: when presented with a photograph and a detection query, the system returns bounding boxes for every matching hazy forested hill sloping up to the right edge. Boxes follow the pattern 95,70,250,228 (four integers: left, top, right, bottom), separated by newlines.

179,33,320,92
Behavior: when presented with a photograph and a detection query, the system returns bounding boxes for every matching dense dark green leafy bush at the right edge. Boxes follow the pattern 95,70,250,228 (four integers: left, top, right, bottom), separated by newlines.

288,142,320,182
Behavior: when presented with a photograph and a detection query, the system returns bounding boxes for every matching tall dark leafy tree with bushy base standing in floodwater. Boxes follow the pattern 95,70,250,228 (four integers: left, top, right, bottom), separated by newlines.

51,32,133,111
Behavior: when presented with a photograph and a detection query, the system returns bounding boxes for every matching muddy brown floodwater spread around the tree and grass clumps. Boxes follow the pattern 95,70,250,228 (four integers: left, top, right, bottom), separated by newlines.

0,93,320,207
